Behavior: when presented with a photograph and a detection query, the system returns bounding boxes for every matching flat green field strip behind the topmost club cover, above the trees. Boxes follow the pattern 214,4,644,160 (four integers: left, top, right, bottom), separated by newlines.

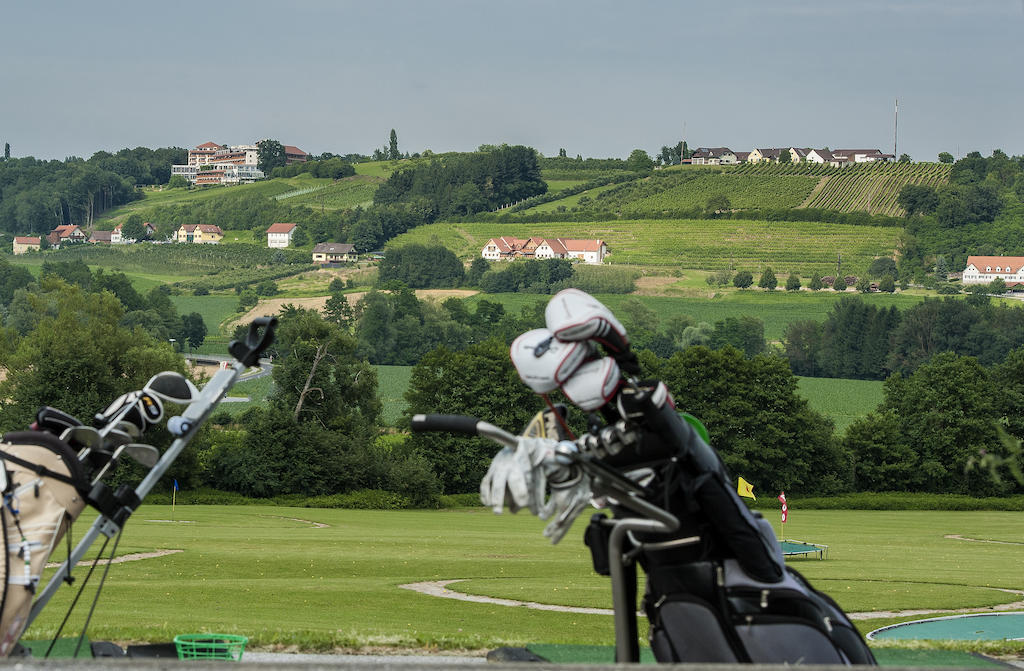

465,290,924,340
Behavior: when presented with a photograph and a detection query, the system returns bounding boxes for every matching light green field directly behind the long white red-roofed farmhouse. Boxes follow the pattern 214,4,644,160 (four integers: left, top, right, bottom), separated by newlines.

389,219,900,278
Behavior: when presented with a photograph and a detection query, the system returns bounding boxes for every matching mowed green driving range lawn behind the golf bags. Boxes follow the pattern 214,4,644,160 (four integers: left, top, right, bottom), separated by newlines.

28,506,1024,649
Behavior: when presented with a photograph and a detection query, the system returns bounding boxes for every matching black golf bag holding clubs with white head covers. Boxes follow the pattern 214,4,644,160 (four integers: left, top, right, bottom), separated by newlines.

585,385,876,665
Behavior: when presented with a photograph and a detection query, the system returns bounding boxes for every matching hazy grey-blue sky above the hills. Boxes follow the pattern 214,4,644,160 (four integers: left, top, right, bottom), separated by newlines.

0,0,1024,161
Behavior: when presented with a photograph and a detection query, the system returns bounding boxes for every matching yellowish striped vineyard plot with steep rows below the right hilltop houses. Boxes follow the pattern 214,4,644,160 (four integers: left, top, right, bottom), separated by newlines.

806,163,950,216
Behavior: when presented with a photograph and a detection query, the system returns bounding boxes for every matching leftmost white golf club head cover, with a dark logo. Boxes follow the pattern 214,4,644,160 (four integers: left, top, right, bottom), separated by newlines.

510,329,594,393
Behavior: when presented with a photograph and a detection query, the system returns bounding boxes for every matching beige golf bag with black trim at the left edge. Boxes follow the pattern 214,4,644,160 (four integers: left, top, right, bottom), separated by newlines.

0,431,89,657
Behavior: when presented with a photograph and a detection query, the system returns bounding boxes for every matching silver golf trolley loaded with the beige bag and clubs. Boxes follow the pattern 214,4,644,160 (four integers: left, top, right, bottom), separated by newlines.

0,318,278,657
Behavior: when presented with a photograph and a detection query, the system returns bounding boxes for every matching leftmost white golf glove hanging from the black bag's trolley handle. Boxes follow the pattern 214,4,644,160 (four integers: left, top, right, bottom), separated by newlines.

480,436,558,515
